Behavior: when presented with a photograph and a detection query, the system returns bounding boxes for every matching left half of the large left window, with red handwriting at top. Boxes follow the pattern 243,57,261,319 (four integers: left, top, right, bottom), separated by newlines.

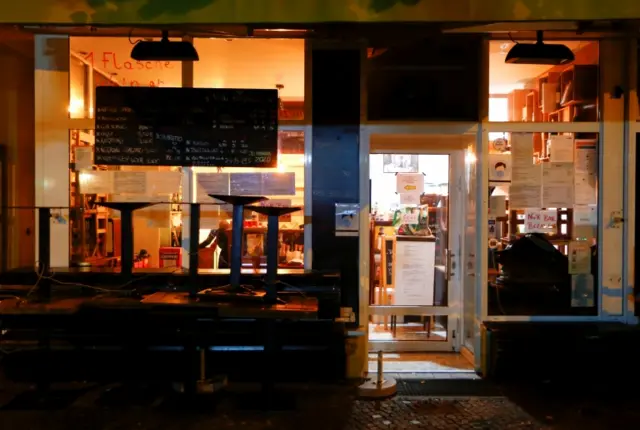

69,37,182,268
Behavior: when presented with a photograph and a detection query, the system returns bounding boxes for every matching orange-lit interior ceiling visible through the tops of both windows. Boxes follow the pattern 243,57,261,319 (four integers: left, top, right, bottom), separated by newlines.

70,35,590,100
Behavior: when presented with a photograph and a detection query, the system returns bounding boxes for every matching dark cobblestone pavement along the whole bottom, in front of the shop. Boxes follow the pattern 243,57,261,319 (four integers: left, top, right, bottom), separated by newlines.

0,374,640,430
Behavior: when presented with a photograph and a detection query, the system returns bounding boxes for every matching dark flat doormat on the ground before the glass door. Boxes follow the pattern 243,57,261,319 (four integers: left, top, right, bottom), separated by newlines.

397,379,503,397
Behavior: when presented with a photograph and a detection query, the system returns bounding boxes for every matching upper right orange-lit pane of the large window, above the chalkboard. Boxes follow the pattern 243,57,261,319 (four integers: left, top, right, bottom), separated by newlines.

194,39,305,120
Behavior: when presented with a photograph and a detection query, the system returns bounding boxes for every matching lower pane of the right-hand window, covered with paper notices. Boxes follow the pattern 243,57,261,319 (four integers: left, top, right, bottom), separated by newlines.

487,133,599,315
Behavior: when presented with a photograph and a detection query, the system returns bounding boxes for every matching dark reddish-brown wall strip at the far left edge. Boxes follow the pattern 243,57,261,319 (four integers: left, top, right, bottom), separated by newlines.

0,34,35,269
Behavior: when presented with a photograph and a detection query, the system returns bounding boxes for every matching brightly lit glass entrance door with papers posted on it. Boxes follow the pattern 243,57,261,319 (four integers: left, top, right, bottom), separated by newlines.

368,148,465,352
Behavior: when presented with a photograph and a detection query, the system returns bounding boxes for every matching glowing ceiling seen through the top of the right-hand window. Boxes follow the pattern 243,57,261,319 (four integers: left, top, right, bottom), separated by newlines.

489,40,591,94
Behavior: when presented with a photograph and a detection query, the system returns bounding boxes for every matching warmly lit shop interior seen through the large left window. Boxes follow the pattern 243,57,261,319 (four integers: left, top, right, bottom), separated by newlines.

68,37,305,269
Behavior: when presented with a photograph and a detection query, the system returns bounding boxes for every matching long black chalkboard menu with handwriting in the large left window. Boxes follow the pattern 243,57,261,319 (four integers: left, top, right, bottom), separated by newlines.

95,87,278,167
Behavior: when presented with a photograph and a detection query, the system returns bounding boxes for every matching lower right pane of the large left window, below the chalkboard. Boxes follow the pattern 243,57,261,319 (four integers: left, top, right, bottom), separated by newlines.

194,131,305,270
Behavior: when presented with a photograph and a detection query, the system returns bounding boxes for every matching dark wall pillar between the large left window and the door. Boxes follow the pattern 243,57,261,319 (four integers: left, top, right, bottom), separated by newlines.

311,48,361,318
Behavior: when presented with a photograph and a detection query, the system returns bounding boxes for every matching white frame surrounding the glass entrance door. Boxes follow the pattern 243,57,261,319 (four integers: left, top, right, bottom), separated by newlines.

359,122,478,352
